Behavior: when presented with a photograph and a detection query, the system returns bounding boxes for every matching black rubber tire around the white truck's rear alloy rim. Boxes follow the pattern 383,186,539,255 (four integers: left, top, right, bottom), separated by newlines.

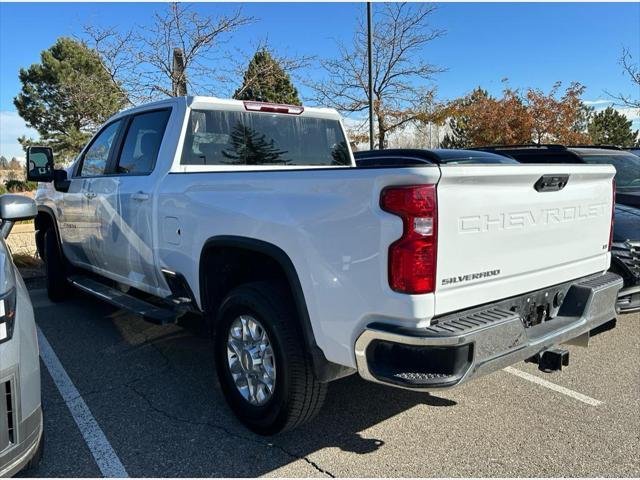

215,282,327,435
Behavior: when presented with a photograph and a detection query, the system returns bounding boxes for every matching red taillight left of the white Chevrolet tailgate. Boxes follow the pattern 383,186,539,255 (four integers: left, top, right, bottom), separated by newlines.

380,185,438,294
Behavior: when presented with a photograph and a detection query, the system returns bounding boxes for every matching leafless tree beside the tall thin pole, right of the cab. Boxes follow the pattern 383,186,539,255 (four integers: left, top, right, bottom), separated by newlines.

311,3,444,148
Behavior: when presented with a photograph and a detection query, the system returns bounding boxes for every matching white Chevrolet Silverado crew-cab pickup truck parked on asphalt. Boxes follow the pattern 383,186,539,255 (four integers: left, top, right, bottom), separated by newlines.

27,97,622,434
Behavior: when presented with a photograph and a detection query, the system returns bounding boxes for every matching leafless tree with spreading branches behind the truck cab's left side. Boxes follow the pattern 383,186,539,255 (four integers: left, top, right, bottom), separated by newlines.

84,3,253,104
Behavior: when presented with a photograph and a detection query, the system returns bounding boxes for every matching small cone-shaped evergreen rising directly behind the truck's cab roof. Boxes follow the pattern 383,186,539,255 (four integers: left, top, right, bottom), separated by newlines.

233,49,300,105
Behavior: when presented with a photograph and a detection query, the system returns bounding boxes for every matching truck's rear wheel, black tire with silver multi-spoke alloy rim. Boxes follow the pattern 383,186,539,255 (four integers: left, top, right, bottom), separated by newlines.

215,282,327,435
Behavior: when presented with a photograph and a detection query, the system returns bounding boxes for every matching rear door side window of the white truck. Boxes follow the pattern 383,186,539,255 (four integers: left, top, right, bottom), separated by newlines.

116,110,171,175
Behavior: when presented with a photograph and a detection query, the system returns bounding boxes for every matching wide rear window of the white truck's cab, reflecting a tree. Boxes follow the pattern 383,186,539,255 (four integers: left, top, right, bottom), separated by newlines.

181,110,351,166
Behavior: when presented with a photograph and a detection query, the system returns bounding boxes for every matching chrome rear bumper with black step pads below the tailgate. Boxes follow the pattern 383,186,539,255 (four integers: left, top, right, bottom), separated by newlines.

355,273,622,391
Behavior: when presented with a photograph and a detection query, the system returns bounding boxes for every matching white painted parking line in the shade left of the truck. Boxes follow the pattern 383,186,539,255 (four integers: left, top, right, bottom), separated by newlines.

38,327,129,478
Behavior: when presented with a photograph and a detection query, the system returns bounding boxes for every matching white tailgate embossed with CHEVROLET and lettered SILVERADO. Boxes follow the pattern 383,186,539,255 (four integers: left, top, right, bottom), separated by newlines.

435,165,615,315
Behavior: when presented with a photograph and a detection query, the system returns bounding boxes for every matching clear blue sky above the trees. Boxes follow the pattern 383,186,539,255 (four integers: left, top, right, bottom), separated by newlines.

0,2,640,157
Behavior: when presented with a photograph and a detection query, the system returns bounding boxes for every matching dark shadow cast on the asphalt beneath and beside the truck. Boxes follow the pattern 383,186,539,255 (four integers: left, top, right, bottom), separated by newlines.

29,290,455,477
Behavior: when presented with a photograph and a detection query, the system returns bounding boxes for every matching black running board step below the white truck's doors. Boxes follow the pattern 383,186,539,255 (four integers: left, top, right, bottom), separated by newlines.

69,275,185,325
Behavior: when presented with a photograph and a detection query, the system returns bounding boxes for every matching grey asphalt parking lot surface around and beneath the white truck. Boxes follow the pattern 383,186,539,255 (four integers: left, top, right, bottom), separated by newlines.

21,288,640,477
